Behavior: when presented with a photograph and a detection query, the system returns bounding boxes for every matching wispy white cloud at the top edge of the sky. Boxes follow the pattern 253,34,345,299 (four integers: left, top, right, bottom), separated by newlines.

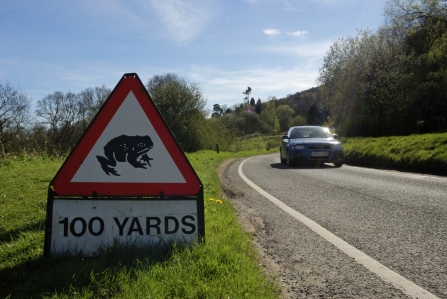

150,0,216,43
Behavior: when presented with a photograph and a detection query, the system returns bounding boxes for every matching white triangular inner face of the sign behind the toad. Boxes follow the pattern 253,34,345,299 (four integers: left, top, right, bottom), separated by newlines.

71,91,186,183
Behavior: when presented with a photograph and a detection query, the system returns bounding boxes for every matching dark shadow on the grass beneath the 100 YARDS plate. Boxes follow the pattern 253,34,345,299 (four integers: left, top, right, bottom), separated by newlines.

0,242,182,298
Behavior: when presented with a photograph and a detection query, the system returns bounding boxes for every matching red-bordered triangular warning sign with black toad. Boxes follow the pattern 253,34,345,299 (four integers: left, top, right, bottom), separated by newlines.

50,74,202,196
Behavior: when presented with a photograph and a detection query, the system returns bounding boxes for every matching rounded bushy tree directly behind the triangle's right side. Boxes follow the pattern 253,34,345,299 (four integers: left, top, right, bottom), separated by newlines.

146,73,207,152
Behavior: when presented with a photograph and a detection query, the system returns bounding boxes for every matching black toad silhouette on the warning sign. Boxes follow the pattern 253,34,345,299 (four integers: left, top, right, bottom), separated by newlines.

96,135,154,176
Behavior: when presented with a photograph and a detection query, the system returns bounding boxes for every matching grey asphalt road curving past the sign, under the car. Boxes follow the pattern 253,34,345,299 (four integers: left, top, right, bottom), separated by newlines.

222,154,447,298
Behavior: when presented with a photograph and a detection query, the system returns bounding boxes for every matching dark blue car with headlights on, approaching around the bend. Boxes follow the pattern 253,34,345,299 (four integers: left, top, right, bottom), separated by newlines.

279,126,343,167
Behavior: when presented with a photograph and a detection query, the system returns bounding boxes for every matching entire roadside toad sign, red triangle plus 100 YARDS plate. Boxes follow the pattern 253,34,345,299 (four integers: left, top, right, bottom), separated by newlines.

44,73,205,256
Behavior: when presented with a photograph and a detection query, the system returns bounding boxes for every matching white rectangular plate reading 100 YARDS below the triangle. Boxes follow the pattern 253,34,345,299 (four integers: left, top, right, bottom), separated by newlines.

51,199,199,256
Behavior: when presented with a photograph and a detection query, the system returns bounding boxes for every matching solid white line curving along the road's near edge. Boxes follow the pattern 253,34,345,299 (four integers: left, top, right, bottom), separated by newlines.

238,158,438,299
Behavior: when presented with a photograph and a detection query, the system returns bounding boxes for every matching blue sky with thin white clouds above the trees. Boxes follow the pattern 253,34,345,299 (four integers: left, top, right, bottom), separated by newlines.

0,0,386,111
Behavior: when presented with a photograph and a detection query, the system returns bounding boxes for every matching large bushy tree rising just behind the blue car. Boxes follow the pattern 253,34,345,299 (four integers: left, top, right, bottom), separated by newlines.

318,29,415,136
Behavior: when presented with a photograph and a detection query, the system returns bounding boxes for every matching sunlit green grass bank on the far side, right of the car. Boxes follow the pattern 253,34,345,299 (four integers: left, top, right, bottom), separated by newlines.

342,133,447,172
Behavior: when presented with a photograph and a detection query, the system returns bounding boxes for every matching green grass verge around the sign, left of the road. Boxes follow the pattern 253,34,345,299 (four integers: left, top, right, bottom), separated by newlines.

0,144,279,298
